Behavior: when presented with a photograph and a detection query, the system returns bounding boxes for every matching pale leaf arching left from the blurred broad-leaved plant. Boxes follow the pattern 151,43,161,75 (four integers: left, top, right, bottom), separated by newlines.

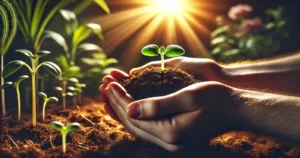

43,30,69,53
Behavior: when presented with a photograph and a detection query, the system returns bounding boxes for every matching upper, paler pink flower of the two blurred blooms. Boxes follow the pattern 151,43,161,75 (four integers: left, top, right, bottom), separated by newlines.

228,4,253,20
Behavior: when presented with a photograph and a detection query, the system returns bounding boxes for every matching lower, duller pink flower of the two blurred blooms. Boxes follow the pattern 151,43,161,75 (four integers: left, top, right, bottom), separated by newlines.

242,18,264,33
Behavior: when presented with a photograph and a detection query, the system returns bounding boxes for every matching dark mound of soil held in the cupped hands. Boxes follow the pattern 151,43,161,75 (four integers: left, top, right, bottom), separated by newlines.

120,67,200,100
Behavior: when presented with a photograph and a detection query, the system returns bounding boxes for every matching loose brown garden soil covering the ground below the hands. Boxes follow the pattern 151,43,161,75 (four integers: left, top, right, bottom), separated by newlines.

0,98,300,158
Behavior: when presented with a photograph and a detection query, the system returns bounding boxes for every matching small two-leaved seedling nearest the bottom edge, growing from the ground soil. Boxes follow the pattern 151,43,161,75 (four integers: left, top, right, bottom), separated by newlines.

50,121,80,153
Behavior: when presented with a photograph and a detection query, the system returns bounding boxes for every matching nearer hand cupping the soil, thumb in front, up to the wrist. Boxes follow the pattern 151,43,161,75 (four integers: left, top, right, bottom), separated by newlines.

104,79,238,151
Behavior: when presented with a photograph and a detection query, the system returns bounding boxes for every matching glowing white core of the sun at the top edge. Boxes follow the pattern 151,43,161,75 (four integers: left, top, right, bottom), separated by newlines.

156,0,182,13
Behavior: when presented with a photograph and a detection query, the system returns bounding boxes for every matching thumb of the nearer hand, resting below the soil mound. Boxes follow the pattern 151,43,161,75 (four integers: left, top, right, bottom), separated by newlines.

127,91,198,119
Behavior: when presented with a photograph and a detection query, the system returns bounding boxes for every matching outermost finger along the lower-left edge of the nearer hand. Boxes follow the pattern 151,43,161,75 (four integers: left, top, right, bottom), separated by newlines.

105,87,180,151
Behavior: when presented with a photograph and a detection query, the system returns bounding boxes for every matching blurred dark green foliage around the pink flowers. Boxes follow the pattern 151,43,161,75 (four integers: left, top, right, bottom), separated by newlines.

211,7,289,62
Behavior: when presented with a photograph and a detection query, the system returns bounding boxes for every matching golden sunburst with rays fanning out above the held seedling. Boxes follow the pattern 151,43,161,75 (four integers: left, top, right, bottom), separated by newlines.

92,0,216,69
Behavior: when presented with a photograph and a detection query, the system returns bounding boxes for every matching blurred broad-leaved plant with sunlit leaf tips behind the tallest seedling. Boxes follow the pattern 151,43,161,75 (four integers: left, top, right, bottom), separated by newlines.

43,9,103,80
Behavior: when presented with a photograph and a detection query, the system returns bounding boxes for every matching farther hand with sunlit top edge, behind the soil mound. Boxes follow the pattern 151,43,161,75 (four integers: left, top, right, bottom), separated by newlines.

130,57,226,83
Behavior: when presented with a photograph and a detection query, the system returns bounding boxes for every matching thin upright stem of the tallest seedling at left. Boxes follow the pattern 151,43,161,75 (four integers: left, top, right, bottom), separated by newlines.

31,60,36,127
